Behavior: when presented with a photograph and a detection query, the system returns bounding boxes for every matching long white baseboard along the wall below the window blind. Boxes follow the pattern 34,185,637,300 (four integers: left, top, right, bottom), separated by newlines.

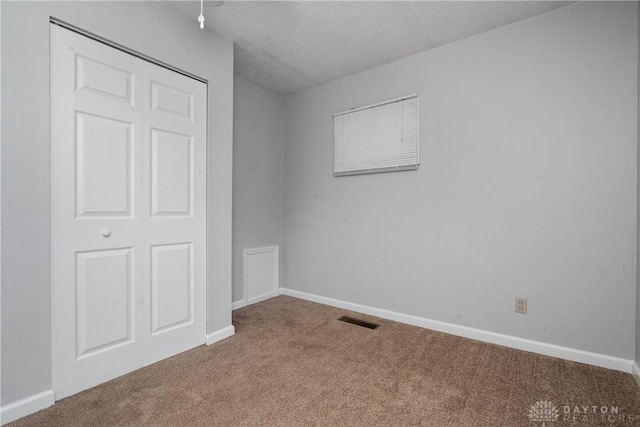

280,288,637,373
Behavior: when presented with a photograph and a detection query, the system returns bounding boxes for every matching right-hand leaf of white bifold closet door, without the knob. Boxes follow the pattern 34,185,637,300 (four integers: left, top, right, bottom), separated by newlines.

143,60,207,355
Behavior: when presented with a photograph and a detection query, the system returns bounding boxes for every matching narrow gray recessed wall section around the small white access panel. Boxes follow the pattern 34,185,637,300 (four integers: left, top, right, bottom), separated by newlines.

233,77,284,301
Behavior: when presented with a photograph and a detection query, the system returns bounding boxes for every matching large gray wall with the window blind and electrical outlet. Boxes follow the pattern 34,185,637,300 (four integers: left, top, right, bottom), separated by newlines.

283,2,638,359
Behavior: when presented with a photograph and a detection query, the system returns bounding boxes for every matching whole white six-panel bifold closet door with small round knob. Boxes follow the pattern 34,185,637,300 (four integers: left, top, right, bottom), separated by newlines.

51,25,207,399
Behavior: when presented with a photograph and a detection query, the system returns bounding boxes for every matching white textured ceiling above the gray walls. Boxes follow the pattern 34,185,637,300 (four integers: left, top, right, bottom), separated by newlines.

167,0,572,96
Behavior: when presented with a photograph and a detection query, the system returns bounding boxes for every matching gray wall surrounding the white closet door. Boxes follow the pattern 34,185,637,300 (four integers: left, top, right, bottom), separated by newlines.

0,1,233,405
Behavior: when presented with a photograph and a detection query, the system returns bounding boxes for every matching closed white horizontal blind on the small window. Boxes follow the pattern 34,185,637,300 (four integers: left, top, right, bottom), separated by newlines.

333,94,420,176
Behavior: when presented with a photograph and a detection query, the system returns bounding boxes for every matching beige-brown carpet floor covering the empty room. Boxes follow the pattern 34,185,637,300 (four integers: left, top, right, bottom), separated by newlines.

10,296,640,427
